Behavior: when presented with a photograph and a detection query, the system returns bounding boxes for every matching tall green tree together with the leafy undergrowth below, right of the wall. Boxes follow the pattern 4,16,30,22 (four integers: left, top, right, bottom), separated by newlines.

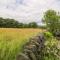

44,10,60,60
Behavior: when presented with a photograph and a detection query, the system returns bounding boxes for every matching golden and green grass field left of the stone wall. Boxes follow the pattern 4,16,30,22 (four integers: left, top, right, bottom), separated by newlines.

0,28,43,60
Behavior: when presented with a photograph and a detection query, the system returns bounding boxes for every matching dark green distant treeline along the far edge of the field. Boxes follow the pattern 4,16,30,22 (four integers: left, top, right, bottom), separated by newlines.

0,17,45,28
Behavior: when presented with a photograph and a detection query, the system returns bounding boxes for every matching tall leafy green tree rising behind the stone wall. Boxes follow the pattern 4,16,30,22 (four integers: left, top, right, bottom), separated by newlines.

44,10,60,33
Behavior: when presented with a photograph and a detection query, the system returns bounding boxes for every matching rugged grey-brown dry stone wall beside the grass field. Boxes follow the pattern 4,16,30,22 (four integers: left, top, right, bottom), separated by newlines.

16,33,45,60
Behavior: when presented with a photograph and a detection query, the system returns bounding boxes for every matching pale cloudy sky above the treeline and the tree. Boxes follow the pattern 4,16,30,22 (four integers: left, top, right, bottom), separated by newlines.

0,0,60,23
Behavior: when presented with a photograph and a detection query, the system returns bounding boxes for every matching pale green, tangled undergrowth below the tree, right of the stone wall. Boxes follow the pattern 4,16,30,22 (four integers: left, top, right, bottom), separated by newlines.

44,33,60,60
